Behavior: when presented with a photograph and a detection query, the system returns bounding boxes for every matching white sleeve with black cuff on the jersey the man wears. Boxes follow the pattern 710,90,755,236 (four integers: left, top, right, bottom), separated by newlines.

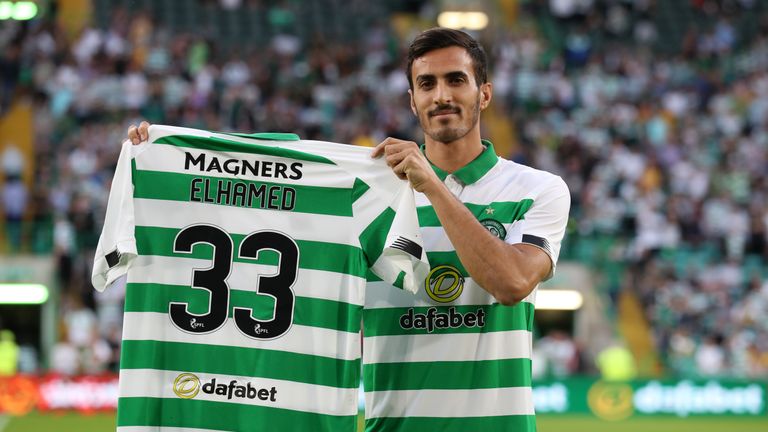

520,177,571,280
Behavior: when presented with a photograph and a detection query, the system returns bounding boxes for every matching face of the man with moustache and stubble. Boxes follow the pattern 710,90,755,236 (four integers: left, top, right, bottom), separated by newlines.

408,47,491,143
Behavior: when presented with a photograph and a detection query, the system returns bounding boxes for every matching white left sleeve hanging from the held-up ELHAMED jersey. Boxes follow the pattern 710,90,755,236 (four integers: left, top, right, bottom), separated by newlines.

91,141,137,291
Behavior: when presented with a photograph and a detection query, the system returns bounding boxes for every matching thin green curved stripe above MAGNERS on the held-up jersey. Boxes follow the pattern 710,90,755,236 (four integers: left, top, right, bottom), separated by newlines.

155,135,336,165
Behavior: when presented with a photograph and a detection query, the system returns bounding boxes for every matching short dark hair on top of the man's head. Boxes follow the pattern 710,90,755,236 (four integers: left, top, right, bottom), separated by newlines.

405,27,488,90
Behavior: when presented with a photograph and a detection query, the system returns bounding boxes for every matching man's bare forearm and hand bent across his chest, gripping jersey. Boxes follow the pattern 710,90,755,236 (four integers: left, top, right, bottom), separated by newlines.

371,138,552,305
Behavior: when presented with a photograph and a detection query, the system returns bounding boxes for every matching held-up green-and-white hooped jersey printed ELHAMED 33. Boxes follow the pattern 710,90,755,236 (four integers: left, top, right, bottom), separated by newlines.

93,126,429,432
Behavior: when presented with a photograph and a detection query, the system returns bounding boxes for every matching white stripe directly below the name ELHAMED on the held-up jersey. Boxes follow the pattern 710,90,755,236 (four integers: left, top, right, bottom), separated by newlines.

133,198,364,247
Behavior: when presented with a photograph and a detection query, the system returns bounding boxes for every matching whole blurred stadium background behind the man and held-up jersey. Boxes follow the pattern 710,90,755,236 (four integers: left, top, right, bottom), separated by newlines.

0,0,768,431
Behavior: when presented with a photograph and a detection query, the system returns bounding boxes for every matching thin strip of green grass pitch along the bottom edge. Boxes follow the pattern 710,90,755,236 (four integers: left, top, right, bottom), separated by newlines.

0,413,768,432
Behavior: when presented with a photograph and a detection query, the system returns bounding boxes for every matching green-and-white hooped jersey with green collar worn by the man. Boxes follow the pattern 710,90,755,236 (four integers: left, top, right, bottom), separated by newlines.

363,141,570,432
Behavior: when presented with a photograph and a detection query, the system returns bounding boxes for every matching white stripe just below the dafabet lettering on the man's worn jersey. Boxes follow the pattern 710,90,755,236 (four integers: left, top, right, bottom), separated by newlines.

363,330,531,364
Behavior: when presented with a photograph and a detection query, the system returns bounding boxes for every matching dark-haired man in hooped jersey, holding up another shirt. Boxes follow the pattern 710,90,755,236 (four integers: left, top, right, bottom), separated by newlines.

129,28,570,432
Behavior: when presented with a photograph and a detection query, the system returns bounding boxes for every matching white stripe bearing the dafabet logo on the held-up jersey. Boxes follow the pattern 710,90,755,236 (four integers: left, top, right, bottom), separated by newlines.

120,369,358,415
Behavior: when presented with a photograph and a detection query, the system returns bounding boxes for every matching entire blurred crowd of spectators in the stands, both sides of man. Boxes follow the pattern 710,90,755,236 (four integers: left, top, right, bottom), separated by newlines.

0,0,768,376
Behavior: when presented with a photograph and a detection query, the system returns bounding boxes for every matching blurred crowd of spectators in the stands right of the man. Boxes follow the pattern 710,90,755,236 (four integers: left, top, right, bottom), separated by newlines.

510,2,768,377
